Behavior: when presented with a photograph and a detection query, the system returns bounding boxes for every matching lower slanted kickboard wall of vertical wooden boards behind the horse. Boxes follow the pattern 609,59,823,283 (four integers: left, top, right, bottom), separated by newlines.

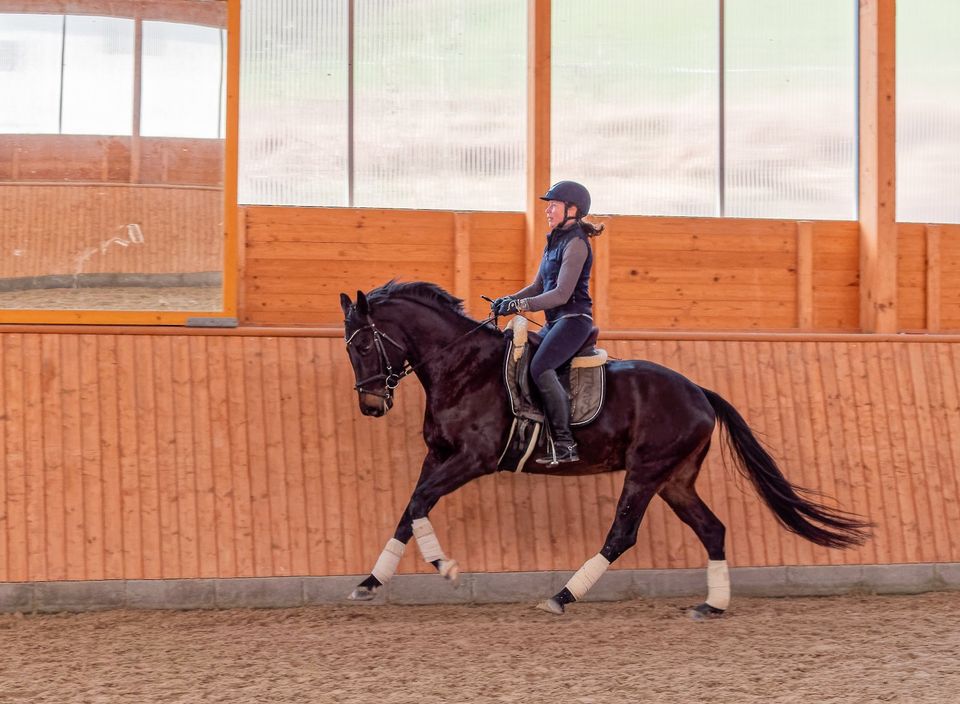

0,331,960,581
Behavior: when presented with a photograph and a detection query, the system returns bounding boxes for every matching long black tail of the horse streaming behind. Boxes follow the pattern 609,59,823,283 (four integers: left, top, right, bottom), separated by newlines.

701,387,871,548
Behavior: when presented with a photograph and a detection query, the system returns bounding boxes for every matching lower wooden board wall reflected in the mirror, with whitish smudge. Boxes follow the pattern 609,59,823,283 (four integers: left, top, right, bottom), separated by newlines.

0,183,224,277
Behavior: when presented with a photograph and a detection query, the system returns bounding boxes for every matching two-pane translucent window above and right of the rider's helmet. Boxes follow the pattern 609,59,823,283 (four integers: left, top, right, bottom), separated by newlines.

551,0,857,219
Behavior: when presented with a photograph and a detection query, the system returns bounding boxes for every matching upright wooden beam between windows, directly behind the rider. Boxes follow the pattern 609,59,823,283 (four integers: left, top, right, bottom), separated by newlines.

524,0,551,281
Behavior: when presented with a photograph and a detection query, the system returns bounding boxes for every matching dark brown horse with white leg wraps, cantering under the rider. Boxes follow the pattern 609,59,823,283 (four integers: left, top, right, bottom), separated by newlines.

340,282,868,617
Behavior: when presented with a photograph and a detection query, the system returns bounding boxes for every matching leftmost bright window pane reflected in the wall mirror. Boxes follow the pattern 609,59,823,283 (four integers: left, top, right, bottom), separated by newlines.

0,14,63,134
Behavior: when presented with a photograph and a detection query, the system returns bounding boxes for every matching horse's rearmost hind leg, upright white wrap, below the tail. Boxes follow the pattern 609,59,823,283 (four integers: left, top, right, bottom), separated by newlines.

660,450,730,619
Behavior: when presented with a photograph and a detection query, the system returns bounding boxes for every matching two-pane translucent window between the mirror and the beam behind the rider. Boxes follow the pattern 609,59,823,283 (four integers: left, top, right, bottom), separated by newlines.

239,0,526,210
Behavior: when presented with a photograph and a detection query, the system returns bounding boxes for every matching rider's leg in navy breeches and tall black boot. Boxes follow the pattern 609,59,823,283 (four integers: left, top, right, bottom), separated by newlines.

530,317,593,465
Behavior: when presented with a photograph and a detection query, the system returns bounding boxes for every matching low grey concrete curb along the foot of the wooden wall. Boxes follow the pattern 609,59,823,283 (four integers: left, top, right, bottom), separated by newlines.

0,562,960,613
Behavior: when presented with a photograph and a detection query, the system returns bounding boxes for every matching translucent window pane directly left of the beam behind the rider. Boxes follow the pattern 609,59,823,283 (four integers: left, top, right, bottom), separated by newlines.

354,0,527,210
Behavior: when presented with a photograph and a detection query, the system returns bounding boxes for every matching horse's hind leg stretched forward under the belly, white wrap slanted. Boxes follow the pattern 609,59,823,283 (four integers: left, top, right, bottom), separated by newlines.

537,467,657,615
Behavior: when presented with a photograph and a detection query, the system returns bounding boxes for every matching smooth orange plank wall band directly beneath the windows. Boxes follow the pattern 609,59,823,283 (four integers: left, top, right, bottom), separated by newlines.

240,207,960,331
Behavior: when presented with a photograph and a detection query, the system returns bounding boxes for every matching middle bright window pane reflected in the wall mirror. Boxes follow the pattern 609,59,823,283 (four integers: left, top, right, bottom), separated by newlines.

60,15,134,135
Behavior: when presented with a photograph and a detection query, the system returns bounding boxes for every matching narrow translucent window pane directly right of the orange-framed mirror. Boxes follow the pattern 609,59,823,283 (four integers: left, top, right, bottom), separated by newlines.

239,0,348,205
